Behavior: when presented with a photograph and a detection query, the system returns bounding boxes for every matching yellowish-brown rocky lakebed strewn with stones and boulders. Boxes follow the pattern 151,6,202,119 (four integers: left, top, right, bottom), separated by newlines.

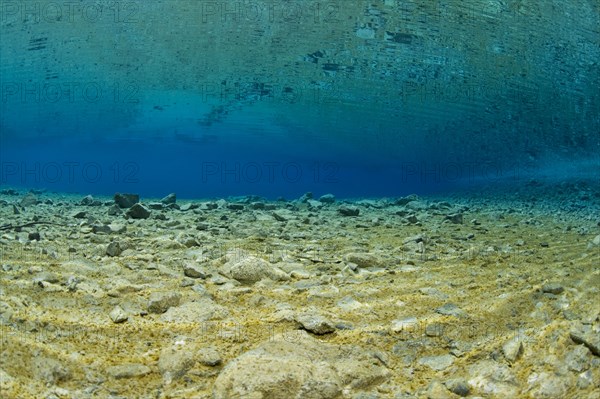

0,183,600,399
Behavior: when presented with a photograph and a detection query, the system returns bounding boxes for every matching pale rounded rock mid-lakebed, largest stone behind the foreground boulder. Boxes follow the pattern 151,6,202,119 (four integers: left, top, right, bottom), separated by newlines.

219,256,290,283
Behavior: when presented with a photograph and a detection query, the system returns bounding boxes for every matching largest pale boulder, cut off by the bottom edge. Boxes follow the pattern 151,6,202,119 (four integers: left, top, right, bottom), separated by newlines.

213,330,390,399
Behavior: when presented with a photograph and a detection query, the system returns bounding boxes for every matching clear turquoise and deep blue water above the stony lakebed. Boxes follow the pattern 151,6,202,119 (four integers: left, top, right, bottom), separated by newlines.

0,0,600,199
